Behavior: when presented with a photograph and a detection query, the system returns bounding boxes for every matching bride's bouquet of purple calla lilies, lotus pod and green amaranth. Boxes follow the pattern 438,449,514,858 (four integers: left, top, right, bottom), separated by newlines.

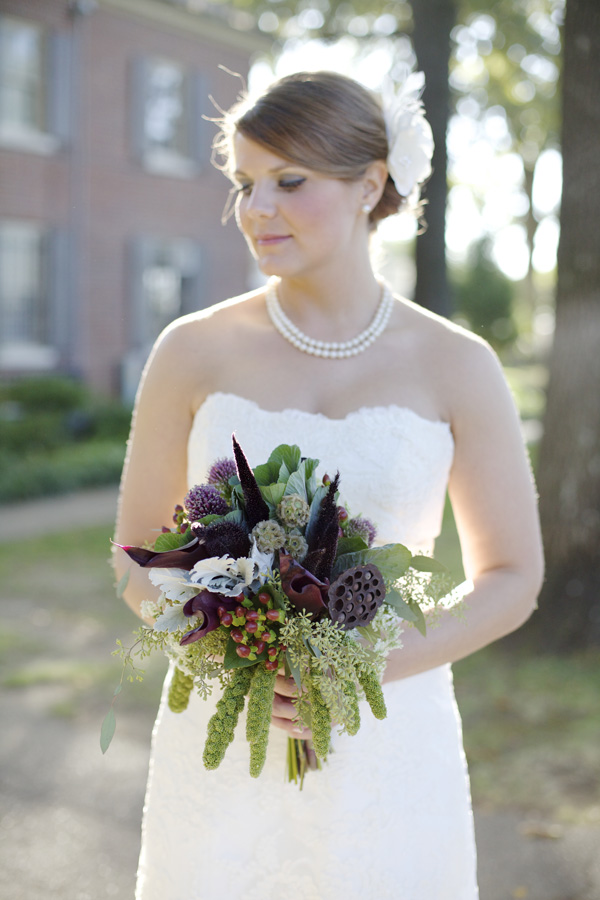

101,437,448,780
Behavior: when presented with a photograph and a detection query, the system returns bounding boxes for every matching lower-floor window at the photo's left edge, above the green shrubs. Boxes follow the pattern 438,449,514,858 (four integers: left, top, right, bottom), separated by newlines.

0,221,58,371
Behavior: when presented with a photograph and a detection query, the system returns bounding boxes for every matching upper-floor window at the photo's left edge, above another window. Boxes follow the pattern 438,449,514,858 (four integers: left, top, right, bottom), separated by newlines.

0,15,71,153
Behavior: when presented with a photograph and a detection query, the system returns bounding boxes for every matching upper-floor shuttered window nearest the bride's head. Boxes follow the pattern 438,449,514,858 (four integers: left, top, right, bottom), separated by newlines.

132,58,210,177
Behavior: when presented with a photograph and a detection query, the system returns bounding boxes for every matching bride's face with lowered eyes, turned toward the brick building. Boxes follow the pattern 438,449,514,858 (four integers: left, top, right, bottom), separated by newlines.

233,134,368,277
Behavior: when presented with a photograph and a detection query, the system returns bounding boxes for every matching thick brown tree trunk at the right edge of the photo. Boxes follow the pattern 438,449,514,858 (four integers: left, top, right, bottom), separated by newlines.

527,0,600,650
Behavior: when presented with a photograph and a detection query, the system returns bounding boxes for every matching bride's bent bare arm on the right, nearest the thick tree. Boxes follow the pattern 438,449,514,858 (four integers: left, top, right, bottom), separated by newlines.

384,341,543,681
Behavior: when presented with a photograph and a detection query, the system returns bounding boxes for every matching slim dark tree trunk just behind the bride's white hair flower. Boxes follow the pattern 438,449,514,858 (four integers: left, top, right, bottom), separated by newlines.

412,0,456,316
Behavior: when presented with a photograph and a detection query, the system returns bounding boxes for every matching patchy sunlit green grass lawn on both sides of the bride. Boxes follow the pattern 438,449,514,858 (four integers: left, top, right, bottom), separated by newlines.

0,523,600,822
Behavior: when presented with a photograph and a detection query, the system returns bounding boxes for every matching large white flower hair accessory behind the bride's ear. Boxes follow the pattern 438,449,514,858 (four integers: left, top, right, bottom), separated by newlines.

381,72,433,198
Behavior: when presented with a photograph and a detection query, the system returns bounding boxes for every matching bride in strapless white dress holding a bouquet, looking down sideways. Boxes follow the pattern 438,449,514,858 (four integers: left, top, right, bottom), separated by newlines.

116,72,543,900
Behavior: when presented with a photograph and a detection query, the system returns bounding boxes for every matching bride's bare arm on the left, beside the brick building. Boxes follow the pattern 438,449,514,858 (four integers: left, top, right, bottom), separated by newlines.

113,322,194,615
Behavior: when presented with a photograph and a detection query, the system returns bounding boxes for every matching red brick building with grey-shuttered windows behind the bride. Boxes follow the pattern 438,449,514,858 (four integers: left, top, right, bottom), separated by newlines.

0,0,266,399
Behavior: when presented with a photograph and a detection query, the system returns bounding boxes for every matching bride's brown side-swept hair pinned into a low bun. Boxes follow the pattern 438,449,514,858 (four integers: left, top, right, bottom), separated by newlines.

213,72,405,228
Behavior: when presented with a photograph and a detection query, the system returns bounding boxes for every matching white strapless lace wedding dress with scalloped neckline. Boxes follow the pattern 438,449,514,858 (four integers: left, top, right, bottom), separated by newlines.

136,393,478,900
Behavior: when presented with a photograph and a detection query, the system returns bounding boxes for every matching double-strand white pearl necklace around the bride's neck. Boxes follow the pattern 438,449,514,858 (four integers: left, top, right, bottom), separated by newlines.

265,281,394,359
